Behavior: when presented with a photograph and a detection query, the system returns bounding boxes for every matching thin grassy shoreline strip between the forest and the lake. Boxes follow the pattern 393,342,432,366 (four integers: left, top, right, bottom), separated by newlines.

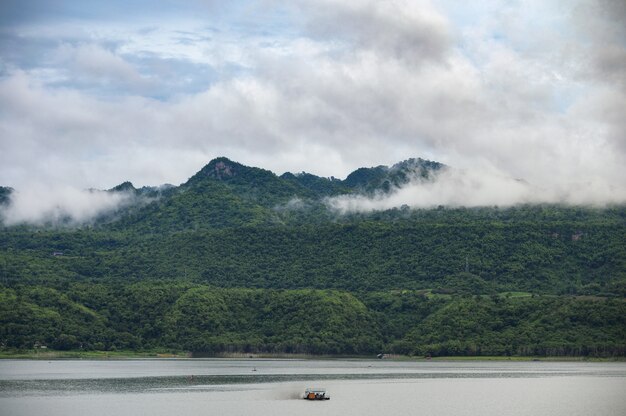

0,350,626,362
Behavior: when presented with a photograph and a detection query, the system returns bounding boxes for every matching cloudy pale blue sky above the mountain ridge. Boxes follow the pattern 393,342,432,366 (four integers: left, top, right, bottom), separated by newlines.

0,0,626,218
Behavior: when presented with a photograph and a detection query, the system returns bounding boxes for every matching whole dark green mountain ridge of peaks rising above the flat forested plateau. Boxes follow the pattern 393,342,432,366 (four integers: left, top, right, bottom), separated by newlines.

103,157,444,232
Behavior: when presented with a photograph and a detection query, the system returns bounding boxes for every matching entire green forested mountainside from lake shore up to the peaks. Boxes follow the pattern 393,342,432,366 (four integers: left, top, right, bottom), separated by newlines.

0,158,626,356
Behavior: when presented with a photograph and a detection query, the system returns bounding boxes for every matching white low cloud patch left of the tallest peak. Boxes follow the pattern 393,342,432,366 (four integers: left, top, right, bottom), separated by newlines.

0,185,136,226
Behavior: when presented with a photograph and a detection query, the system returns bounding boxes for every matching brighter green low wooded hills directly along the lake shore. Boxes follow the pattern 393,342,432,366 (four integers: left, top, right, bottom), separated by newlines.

0,283,626,357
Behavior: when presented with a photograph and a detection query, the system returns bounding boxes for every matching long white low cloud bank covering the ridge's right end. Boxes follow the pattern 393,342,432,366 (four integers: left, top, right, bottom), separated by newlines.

326,169,626,213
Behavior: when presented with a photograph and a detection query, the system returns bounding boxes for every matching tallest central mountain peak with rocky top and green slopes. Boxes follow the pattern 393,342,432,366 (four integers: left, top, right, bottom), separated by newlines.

108,158,294,232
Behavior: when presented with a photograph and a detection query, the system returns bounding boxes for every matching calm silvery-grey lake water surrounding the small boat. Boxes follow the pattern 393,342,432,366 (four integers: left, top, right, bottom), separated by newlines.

0,359,626,416
